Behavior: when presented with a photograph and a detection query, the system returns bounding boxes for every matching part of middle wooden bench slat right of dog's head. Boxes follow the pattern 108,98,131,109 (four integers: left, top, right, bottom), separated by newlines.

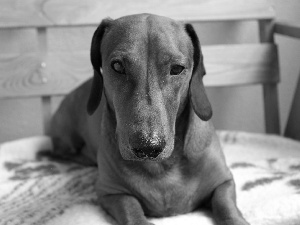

203,44,279,87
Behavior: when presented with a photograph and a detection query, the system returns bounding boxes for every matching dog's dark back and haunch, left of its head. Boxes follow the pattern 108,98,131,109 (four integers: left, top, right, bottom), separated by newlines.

47,79,101,165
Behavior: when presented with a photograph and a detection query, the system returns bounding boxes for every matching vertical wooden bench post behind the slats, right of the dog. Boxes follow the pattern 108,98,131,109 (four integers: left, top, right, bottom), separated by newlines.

259,20,280,134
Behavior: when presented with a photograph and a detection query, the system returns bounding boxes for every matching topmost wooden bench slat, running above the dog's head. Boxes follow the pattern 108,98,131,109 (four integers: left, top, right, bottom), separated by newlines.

0,0,274,28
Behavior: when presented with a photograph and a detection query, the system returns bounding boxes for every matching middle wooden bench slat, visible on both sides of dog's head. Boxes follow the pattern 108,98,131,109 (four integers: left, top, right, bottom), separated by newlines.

0,44,279,98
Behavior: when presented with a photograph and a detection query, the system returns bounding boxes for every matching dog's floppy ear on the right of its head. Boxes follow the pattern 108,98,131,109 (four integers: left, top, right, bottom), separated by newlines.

185,24,212,121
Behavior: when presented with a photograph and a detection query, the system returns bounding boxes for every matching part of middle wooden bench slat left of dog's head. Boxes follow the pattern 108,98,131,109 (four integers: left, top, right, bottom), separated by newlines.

0,52,92,98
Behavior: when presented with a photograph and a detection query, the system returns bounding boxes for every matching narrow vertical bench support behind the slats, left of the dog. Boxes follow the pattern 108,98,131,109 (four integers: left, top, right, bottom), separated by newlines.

37,27,51,134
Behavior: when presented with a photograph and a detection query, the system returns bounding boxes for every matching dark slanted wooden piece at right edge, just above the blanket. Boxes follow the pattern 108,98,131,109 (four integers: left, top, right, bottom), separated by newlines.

284,71,300,141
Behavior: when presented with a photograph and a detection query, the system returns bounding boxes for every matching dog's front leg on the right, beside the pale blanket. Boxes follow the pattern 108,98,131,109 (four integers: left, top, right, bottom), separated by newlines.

211,180,249,225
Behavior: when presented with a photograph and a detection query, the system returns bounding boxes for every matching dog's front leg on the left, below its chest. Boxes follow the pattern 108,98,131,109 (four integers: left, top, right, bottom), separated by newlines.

100,194,153,225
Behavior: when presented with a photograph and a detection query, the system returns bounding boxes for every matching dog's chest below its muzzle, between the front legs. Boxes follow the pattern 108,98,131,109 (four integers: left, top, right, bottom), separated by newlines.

124,163,206,217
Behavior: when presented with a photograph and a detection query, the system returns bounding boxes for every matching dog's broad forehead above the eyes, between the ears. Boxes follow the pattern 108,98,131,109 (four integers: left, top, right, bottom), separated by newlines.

107,15,190,76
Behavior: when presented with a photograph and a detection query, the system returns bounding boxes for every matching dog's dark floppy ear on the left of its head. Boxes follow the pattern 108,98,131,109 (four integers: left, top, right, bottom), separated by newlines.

87,19,112,115
